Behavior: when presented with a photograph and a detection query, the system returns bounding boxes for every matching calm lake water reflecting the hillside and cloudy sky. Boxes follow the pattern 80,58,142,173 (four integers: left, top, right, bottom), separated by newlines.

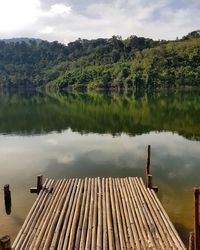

0,92,200,246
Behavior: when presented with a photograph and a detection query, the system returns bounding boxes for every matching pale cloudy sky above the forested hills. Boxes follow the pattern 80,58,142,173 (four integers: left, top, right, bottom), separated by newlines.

0,0,200,44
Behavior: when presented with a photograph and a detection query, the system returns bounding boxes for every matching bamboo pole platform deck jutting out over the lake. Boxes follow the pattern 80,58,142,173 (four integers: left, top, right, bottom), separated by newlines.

12,177,186,250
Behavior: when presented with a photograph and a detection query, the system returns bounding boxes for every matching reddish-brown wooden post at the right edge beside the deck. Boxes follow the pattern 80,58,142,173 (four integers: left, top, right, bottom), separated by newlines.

193,187,200,250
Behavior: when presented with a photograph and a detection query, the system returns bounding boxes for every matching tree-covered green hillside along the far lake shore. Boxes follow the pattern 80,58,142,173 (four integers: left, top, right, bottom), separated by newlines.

0,31,200,89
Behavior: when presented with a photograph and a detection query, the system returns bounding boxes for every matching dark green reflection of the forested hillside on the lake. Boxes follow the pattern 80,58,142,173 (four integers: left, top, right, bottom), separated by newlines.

0,92,200,140
